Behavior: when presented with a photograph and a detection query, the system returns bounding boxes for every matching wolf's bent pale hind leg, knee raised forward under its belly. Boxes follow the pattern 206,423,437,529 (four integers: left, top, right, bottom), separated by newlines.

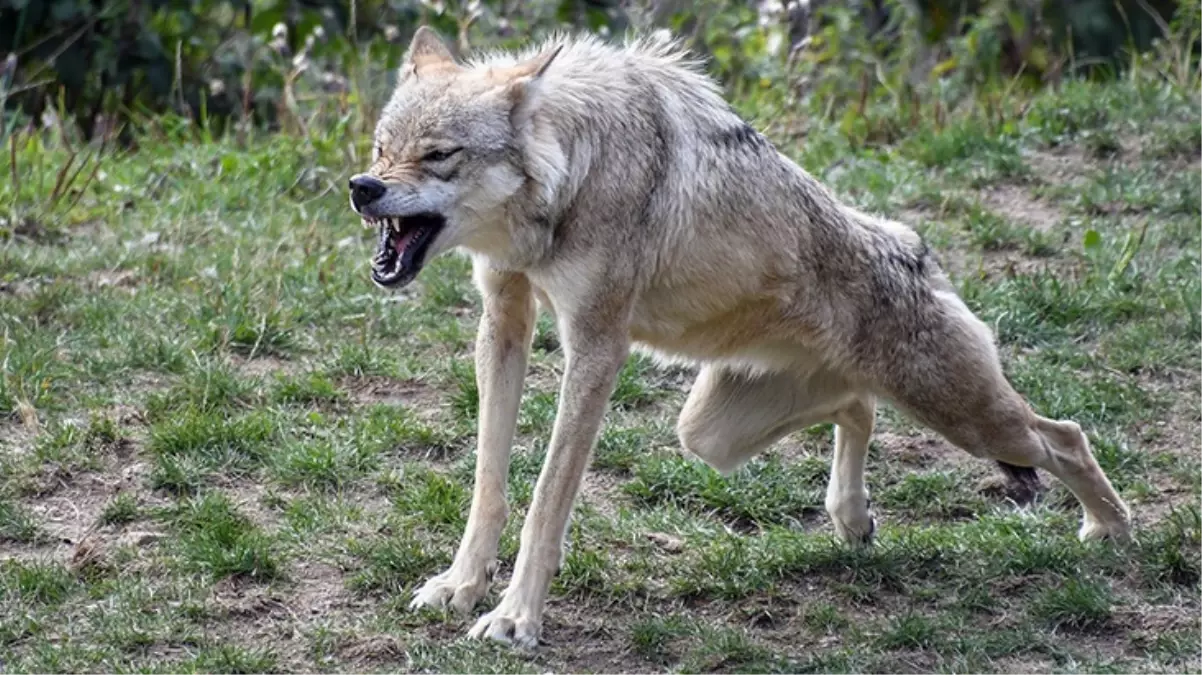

677,365,875,543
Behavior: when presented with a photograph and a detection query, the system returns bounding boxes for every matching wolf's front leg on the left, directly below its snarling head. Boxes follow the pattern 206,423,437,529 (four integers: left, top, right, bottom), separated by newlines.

410,265,535,613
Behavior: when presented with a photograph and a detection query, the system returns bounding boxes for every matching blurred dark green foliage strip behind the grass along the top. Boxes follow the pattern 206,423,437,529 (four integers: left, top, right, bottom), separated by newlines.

0,0,1202,144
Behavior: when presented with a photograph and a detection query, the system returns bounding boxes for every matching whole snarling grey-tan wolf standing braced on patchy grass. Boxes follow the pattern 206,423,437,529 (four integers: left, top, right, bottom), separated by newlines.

349,26,1131,647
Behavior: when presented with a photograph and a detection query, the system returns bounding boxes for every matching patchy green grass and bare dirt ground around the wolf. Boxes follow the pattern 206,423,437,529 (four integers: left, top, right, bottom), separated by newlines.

0,76,1202,674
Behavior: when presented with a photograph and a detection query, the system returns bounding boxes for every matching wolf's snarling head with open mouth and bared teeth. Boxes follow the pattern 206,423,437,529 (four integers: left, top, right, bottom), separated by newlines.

350,26,558,287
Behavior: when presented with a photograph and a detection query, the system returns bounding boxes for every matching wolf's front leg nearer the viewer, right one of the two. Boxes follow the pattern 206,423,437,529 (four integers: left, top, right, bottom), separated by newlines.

469,322,630,649
